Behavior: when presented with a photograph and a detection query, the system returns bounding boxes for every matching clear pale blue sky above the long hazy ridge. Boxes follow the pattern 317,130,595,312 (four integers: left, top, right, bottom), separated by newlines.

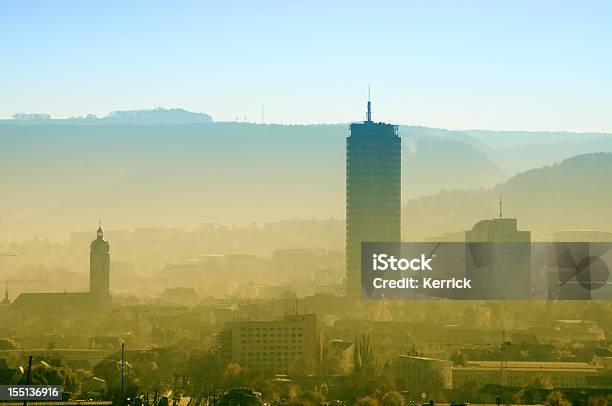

0,0,612,131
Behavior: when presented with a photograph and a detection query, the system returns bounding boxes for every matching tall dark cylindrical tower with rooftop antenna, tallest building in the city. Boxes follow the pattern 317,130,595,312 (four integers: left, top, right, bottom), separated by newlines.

346,95,401,297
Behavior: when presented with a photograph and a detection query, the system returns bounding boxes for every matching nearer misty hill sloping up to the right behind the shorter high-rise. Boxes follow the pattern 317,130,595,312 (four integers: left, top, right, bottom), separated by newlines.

402,153,612,241
